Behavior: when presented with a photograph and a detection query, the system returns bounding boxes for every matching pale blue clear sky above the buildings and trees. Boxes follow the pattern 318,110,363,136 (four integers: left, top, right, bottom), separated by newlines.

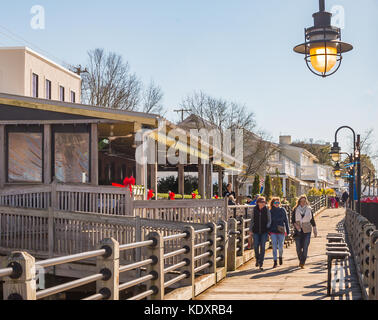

0,0,378,168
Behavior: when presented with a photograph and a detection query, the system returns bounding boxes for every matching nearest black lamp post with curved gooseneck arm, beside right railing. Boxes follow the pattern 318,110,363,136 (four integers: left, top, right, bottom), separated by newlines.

330,126,361,213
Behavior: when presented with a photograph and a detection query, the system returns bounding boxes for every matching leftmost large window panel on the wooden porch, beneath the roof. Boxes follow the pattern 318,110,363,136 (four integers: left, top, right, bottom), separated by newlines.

8,132,43,182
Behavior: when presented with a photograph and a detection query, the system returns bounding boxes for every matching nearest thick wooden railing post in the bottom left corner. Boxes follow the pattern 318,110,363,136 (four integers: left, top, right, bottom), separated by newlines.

3,252,37,300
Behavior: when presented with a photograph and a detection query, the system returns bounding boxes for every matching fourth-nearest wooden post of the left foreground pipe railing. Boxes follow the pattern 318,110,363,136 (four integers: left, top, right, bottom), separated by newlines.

181,227,195,299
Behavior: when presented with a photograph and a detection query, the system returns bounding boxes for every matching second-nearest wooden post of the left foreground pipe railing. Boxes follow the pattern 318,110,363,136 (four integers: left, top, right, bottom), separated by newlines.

96,238,119,300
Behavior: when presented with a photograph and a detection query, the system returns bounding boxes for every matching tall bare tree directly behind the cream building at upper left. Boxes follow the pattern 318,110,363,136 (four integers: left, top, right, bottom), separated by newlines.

83,49,141,110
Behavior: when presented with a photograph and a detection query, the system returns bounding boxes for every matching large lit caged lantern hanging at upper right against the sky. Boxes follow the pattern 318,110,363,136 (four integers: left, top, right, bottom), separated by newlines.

294,0,353,78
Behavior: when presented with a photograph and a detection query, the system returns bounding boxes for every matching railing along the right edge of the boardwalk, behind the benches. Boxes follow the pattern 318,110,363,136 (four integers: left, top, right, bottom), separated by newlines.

345,209,378,300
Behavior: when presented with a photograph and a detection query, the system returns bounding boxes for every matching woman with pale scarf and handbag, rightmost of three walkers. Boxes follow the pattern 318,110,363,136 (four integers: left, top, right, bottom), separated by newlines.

292,196,318,269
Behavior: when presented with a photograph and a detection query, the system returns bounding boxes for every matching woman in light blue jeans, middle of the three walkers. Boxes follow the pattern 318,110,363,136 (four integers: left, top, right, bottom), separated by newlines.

269,198,290,268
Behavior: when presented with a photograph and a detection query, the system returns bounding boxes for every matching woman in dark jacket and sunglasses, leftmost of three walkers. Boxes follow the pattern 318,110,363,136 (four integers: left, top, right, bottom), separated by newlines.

249,197,272,271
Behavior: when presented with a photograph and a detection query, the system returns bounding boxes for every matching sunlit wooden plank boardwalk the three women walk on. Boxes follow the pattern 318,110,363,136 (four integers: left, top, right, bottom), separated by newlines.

197,209,362,300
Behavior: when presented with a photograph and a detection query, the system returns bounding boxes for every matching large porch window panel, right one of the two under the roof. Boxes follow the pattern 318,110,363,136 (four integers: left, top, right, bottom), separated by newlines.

55,132,89,183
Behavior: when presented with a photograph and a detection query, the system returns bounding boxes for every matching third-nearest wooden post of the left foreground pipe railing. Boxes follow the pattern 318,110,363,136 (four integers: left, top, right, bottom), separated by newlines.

147,232,165,300
